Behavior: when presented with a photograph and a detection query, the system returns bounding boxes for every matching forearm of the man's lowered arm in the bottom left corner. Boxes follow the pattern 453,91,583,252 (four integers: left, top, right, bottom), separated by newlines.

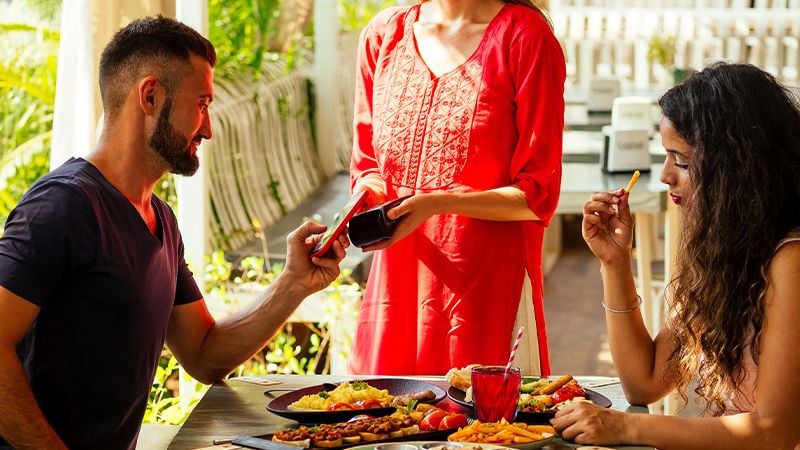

0,348,67,450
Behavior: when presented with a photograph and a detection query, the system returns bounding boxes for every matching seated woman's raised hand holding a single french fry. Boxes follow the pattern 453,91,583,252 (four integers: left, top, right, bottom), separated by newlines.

583,189,633,264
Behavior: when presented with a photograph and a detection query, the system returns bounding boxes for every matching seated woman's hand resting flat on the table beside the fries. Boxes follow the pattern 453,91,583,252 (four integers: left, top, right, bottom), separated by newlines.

550,402,636,445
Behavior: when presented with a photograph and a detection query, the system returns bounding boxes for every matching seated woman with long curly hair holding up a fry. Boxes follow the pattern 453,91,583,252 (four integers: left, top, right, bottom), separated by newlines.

552,63,800,450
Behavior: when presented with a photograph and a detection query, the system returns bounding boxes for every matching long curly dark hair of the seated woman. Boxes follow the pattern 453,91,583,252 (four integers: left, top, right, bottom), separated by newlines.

659,63,800,415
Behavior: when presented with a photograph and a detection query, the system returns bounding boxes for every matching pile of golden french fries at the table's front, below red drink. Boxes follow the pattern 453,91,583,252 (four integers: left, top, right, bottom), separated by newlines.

447,419,555,444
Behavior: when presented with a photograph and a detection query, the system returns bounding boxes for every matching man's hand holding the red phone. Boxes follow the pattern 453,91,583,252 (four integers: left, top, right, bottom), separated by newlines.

284,222,350,294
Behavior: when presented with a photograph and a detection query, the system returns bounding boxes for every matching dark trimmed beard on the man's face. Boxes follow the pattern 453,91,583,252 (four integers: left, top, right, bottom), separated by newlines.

147,98,200,176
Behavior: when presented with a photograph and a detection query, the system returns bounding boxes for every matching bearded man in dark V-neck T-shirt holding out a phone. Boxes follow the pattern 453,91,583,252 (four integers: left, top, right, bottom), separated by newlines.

0,17,348,449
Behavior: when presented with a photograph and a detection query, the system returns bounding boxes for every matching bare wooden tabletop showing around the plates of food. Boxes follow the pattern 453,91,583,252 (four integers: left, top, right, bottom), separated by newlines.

168,375,652,450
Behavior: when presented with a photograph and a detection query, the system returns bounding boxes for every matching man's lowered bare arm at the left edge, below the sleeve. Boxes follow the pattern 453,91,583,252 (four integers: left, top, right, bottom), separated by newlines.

0,286,67,449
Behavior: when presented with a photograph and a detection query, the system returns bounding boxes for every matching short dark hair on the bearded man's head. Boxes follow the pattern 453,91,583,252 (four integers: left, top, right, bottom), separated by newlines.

100,16,217,119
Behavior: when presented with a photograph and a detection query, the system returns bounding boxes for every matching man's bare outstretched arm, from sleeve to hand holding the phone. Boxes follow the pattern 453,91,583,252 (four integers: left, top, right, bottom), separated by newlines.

167,222,349,383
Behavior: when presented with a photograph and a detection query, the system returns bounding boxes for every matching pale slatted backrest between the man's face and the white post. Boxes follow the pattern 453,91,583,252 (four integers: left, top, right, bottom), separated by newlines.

204,62,325,250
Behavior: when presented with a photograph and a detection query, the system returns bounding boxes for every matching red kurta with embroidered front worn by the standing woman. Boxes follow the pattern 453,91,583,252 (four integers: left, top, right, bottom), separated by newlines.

349,4,565,374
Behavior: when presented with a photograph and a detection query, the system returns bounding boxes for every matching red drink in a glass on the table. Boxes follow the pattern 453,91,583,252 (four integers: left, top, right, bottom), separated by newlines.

472,366,522,423
